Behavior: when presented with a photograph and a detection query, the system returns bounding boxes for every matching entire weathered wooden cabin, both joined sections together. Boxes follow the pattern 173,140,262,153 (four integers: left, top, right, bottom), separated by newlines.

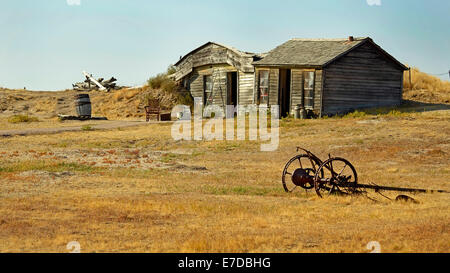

175,37,407,116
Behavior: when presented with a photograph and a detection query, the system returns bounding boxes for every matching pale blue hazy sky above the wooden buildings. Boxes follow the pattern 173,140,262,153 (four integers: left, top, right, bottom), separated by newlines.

0,0,450,90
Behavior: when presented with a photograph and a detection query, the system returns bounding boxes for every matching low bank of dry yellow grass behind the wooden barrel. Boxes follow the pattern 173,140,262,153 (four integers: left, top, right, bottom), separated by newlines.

0,86,177,120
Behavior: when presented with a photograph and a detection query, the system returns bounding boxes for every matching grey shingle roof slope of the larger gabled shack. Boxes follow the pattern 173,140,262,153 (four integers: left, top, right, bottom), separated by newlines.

253,37,370,66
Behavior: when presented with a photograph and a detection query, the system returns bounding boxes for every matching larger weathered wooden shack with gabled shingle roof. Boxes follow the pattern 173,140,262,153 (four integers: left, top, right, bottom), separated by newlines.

253,37,407,115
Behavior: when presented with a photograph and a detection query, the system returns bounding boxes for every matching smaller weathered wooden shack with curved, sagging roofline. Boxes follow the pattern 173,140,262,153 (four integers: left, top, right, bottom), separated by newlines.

173,42,258,115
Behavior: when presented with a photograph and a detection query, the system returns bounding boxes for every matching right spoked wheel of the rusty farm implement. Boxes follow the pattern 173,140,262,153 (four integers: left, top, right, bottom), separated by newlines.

314,157,358,197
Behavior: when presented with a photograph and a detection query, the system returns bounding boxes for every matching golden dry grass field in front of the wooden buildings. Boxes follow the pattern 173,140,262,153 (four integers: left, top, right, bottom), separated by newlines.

0,107,450,252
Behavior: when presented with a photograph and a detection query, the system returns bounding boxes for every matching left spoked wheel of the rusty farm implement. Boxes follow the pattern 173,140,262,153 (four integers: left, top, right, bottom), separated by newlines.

282,154,323,192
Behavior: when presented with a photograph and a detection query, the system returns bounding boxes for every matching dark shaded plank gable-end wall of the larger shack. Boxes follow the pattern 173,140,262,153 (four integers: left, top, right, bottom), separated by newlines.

323,44,403,114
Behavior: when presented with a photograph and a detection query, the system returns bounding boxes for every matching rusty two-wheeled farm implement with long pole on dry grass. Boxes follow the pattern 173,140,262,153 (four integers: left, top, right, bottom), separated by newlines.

282,147,448,200
